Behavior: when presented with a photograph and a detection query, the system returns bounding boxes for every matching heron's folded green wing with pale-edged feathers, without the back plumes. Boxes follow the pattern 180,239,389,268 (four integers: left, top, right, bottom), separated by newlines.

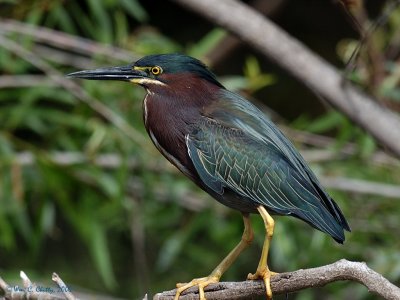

186,118,344,241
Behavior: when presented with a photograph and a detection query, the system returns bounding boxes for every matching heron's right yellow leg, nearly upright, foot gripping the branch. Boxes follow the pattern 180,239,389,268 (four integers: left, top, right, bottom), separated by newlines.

247,206,275,300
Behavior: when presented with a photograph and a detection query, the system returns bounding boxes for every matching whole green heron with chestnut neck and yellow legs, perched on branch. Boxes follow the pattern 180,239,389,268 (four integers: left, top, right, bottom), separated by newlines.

68,54,350,299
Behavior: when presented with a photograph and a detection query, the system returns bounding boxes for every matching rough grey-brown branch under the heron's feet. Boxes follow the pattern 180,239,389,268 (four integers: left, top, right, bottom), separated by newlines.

153,259,400,300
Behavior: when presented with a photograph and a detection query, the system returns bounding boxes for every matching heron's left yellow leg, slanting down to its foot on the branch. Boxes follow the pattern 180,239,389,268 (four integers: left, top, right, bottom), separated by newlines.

175,214,254,300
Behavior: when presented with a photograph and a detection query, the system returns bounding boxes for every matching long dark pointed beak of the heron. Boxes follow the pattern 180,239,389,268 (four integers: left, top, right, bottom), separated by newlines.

67,65,147,81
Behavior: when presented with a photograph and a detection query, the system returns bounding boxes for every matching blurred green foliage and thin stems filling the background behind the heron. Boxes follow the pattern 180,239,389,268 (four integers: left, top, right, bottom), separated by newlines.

0,0,400,299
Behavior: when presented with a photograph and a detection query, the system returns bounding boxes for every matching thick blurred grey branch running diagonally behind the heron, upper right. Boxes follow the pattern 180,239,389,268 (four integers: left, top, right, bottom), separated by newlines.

173,0,400,157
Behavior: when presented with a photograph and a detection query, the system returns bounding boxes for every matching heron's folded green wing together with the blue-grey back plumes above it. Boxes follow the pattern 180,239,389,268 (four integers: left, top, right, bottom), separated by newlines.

186,90,349,242
